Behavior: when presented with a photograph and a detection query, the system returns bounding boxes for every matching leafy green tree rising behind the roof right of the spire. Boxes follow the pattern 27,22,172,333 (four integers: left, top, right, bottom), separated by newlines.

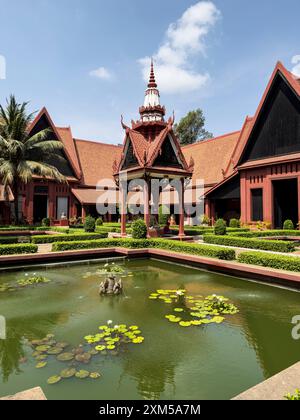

175,109,213,145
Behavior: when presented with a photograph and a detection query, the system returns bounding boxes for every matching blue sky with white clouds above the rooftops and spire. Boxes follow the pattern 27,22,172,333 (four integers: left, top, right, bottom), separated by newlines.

0,0,300,143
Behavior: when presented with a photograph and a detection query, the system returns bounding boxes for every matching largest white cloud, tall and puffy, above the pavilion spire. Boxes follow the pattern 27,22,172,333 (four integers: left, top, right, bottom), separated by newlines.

139,1,221,94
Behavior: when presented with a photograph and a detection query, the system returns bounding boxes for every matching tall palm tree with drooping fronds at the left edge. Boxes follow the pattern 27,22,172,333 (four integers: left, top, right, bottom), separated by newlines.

0,95,66,224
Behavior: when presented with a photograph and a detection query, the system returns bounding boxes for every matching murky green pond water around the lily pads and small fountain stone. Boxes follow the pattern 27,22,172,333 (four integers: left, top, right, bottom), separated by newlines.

0,260,300,400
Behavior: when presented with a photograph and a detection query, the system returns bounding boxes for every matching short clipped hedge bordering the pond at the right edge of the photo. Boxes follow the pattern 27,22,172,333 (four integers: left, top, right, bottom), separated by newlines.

238,252,300,272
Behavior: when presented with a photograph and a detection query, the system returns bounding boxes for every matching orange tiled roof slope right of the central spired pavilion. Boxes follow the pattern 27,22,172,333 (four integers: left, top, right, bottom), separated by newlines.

182,131,240,186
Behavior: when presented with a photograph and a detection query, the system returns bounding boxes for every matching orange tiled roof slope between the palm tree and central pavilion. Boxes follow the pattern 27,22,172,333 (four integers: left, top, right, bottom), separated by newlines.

75,139,122,186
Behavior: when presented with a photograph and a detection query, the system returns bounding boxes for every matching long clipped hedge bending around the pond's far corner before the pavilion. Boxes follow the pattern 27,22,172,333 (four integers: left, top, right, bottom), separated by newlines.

52,238,235,260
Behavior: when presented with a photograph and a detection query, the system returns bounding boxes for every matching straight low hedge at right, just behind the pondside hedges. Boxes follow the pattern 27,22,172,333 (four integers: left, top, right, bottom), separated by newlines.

203,235,295,252
